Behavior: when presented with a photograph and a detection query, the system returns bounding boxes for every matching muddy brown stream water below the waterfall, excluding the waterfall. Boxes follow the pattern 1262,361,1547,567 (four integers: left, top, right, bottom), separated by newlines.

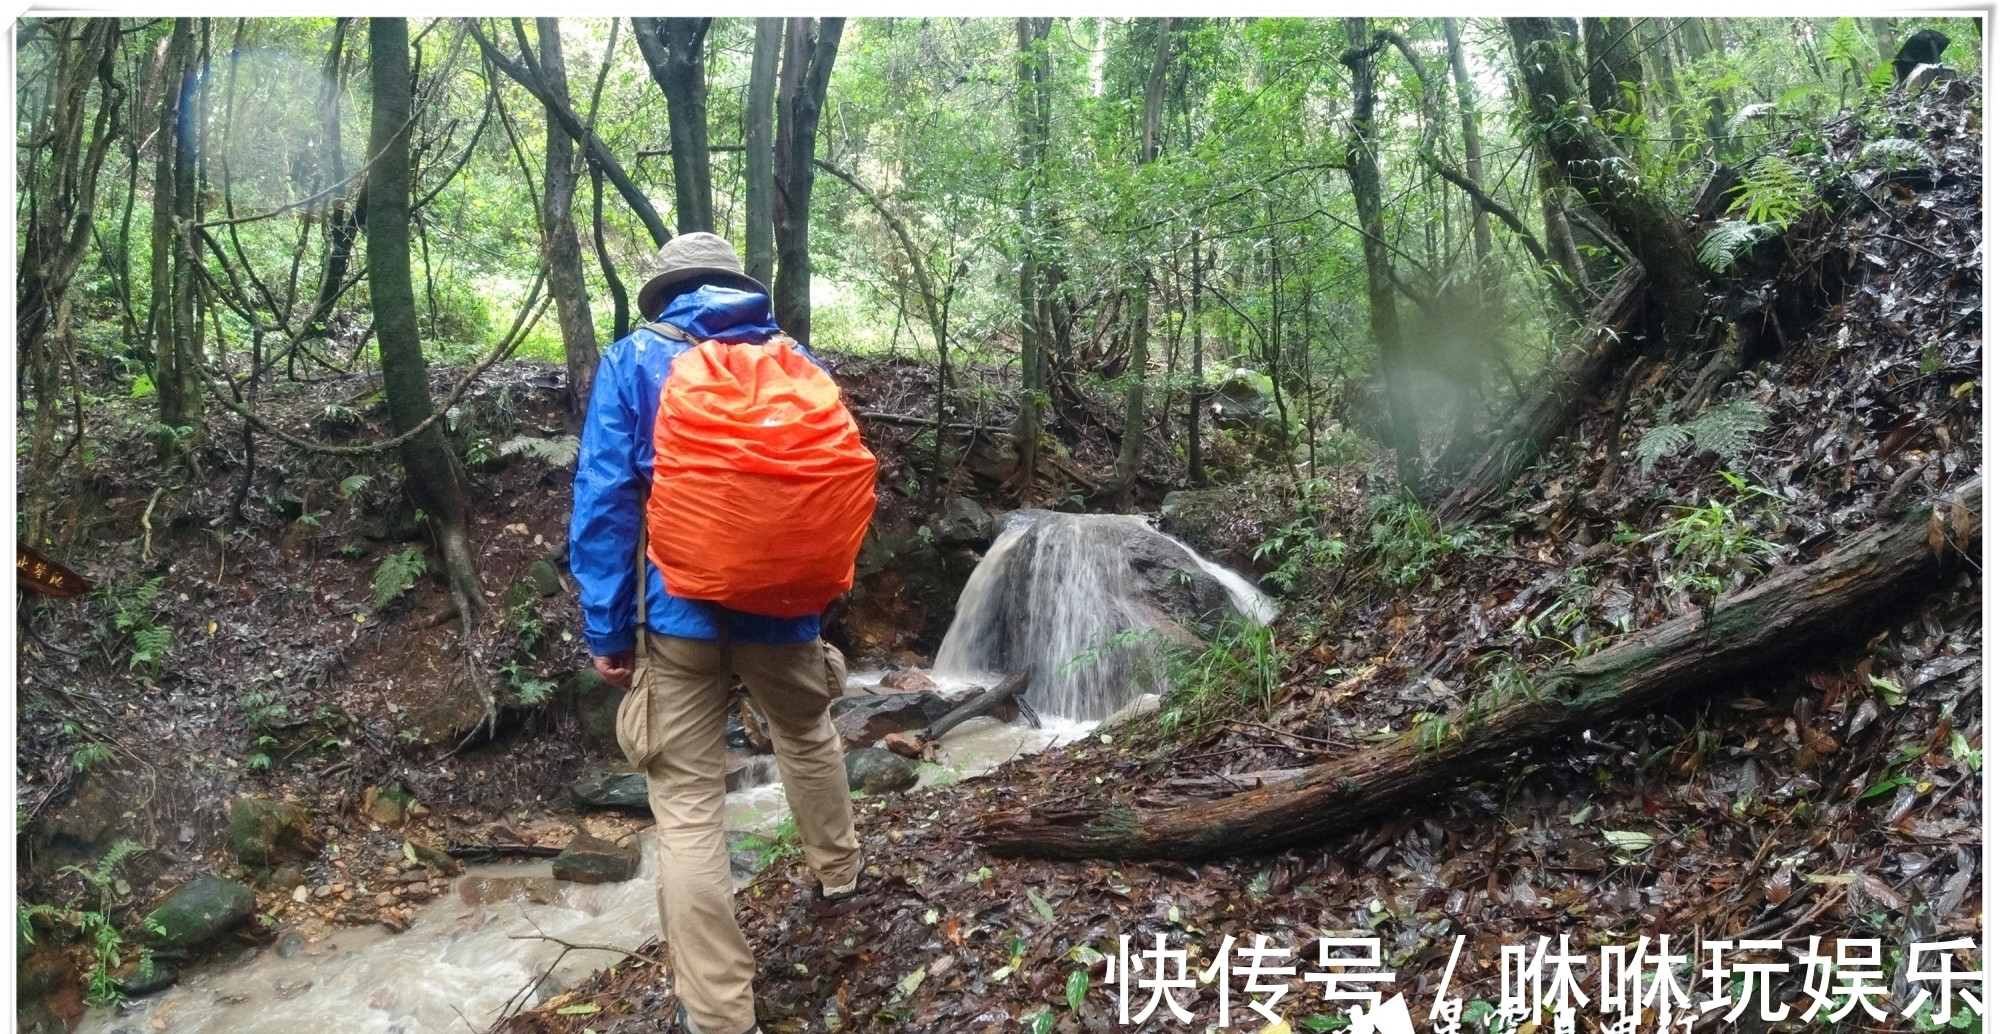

78,672,1088,1034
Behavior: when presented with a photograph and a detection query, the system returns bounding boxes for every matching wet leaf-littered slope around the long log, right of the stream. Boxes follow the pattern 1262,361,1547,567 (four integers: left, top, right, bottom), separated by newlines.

498,84,1984,1034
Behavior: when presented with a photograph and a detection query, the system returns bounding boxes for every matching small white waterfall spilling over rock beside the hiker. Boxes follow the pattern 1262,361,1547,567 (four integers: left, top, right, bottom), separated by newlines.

934,510,1276,720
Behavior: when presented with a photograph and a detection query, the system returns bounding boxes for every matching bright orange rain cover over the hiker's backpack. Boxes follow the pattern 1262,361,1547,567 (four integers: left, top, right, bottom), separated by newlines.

646,336,876,618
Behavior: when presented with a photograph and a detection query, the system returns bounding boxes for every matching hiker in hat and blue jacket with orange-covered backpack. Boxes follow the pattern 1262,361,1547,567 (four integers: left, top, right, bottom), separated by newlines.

570,232,874,1034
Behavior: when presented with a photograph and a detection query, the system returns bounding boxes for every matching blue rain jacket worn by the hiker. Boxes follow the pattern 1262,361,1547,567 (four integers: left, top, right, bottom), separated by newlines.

570,286,824,656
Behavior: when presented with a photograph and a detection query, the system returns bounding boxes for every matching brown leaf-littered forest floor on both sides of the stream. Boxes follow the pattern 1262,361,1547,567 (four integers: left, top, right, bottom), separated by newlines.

16,76,1982,1034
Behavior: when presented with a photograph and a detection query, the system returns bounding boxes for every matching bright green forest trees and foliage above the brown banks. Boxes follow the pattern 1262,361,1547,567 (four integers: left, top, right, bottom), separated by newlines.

16,18,1978,532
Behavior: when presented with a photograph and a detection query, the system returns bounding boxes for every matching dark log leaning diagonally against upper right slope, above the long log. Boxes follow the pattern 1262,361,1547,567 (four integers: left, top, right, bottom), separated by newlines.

1438,266,1646,520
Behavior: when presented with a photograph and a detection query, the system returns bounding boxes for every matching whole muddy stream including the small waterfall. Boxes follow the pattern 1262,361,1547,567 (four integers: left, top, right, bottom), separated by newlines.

78,512,1274,1034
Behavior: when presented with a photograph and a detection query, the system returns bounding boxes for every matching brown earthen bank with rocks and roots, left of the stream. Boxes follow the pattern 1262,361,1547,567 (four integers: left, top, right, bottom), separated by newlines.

16,336,1144,1022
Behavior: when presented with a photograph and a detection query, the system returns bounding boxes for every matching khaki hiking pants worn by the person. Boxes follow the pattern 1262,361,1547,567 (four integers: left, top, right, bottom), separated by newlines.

628,634,860,1034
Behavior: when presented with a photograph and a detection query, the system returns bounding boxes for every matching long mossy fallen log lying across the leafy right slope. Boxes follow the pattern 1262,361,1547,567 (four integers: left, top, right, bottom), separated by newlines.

968,478,1980,860
